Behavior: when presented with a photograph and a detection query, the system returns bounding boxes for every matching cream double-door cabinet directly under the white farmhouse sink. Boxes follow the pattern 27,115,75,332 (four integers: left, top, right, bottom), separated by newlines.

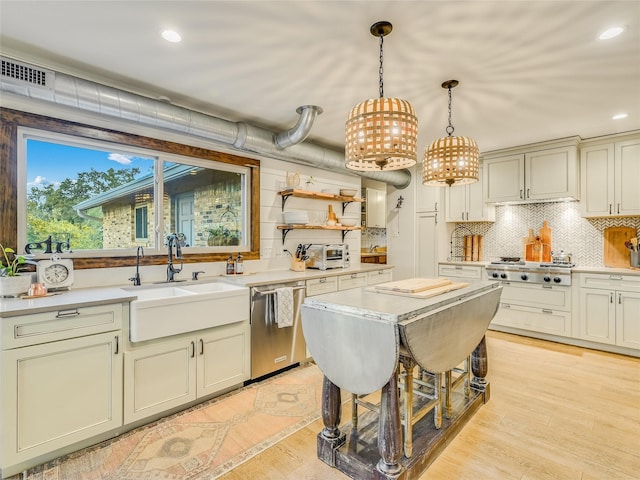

124,322,251,423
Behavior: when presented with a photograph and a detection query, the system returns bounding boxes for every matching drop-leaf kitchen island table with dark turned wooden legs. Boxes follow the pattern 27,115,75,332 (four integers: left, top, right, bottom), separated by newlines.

302,281,502,480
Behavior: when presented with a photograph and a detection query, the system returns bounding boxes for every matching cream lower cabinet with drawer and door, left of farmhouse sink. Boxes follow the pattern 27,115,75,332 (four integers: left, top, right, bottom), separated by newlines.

0,303,128,477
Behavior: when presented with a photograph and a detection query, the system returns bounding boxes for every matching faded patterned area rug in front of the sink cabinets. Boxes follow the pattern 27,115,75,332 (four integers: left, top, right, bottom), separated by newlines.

12,364,322,480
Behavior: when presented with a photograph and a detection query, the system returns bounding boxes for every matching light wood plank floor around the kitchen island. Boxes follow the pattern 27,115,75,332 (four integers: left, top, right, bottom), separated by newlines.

221,332,640,480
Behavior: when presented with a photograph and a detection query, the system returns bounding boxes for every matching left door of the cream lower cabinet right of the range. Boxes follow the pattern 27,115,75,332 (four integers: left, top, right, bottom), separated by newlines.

579,288,616,345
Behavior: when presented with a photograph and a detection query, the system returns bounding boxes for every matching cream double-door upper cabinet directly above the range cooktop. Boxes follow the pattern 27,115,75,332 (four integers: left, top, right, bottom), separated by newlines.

484,140,580,203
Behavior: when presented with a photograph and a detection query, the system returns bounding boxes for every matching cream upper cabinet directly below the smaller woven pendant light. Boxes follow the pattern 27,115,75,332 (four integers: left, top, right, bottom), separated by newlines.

444,161,495,222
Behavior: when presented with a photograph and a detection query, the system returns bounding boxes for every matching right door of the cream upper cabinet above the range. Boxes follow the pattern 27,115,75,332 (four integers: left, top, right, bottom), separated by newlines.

525,147,579,200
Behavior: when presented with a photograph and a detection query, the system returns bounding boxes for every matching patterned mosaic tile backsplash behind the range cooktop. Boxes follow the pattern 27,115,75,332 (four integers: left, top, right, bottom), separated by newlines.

454,202,640,267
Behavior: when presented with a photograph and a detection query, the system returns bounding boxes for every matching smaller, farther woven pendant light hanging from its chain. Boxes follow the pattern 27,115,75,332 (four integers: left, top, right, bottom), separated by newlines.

422,80,479,187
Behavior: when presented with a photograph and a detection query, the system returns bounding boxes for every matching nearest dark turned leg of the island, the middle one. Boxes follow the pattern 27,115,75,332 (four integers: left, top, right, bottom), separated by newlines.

376,371,402,476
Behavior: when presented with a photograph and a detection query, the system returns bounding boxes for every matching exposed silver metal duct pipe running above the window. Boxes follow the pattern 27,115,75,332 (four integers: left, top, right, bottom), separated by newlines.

0,57,411,189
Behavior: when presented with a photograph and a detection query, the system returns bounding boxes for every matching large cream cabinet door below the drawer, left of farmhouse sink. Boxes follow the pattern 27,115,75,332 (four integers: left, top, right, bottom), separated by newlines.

2,332,122,466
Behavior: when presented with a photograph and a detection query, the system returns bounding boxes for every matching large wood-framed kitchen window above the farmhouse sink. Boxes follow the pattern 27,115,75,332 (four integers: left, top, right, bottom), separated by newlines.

0,108,260,268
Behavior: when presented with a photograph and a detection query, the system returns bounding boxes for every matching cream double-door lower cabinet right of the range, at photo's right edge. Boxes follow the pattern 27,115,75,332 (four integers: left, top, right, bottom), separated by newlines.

578,274,640,349
